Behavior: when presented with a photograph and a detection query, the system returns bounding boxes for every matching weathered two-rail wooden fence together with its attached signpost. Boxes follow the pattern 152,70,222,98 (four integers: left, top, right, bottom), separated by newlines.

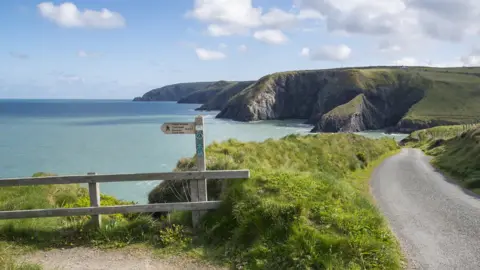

0,116,250,227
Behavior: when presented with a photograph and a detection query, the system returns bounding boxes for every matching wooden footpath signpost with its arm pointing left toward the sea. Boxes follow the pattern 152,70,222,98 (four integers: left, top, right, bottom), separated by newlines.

161,115,208,227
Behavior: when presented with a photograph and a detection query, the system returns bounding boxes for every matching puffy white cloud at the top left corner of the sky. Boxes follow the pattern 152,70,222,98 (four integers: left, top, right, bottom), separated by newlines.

37,2,125,29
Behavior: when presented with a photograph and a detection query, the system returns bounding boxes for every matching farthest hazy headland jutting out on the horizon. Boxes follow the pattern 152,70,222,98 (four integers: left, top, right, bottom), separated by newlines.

133,82,212,101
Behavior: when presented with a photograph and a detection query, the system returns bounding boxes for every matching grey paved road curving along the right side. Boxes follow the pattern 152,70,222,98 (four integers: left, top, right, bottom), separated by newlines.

371,149,480,270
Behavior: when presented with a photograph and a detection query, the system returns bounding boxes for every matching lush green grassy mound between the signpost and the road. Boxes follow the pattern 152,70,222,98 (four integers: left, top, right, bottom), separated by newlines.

149,134,401,269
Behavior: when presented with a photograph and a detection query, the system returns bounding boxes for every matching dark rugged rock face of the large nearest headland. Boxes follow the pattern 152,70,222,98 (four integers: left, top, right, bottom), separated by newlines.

217,69,429,132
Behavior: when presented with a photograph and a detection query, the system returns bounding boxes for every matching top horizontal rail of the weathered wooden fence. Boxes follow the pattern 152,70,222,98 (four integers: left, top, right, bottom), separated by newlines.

0,170,250,187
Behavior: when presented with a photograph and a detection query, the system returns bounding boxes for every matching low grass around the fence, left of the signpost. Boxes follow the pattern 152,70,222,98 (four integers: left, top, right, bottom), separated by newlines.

0,173,206,269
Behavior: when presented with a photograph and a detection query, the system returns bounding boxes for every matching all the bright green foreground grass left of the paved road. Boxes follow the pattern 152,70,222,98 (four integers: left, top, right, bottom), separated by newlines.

0,134,402,269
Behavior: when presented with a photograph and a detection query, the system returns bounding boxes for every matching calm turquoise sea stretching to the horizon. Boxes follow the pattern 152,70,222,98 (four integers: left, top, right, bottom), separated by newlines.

0,100,405,203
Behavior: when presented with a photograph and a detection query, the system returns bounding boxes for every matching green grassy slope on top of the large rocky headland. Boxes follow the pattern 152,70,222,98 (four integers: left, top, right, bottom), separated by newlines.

332,67,480,124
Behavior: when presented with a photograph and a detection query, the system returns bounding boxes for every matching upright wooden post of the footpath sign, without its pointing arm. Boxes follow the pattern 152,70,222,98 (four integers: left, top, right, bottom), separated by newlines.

190,115,208,228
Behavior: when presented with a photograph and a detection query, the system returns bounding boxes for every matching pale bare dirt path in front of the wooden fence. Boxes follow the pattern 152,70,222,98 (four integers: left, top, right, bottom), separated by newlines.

23,247,227,270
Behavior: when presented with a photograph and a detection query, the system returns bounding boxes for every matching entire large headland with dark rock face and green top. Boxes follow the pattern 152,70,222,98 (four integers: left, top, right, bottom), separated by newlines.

217,67,480,132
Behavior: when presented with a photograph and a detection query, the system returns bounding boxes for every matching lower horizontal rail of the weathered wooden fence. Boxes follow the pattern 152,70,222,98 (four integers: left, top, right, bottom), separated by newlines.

0,201,221,219
